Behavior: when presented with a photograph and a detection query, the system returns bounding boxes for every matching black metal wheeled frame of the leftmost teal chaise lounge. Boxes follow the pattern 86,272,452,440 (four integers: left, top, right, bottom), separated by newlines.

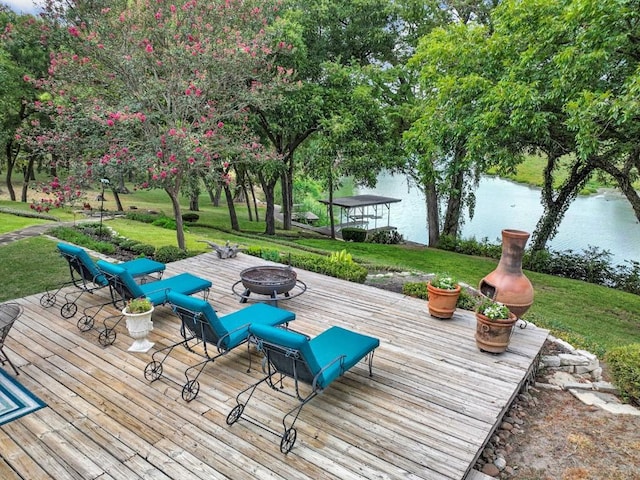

40,252,107,318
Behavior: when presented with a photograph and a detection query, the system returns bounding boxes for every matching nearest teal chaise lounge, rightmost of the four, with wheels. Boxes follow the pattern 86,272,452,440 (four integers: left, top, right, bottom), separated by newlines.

227,324,380,454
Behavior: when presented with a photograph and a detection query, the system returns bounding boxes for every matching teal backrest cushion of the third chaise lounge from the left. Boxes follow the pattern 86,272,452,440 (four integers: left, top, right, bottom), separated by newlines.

167,290,228,348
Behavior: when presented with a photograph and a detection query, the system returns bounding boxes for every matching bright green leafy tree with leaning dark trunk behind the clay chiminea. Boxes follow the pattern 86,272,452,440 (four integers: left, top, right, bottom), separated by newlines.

410,0,640,250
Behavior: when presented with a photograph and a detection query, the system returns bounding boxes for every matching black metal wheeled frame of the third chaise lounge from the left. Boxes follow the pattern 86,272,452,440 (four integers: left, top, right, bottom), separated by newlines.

144,305,251,402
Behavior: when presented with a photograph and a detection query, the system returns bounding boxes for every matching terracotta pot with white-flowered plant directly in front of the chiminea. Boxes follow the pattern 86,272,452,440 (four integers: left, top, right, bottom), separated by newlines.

476,296,518,353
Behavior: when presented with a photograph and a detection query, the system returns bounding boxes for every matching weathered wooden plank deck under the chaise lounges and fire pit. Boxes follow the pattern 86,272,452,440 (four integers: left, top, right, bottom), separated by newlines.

0,253,547,480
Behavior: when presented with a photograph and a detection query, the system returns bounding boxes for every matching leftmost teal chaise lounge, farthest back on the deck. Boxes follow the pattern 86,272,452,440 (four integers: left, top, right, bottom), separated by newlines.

40,243,165,318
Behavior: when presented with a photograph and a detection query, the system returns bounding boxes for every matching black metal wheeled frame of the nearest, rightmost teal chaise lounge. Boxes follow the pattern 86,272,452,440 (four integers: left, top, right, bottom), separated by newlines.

226,332,375,454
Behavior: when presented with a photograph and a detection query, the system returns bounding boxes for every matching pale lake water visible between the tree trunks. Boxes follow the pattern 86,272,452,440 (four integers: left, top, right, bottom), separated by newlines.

354,174,640,264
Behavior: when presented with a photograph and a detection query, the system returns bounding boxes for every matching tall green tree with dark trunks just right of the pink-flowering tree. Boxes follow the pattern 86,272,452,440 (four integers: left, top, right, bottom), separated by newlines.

254,0,397,234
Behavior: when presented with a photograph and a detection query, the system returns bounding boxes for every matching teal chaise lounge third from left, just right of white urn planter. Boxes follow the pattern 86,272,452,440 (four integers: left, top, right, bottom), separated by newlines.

144,291,296,402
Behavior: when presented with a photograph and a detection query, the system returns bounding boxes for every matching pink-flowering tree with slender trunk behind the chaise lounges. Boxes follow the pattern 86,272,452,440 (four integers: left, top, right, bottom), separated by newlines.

43,0,288,249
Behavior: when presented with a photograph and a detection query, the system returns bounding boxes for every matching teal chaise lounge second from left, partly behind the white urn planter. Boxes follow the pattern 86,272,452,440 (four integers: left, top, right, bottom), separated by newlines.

91,260,212,346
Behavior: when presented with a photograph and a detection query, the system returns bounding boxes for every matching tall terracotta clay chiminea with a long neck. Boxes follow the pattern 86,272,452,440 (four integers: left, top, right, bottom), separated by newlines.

479,229,533,318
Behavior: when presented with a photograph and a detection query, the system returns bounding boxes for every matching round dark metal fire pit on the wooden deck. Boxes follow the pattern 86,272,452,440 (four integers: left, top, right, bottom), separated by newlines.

232,266,307,305
